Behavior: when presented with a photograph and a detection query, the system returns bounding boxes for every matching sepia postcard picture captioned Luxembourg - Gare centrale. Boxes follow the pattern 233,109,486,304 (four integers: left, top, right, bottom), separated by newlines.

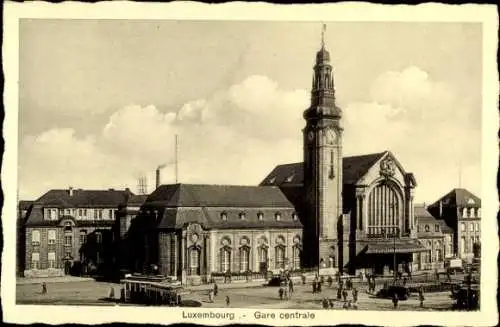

2,1,498,324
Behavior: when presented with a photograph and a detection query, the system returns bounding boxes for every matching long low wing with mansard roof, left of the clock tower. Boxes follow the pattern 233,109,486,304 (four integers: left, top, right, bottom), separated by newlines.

122,184,302,284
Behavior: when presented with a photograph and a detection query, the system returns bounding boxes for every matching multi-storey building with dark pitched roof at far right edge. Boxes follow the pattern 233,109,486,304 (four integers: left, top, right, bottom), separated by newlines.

428,188,481,262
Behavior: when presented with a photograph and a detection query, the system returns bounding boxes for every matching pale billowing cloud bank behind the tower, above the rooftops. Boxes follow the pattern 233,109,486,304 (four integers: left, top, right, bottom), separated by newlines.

20,67,480,200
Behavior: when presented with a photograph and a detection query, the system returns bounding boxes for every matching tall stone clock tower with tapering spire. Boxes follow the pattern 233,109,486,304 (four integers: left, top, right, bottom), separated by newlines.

303,28,342,267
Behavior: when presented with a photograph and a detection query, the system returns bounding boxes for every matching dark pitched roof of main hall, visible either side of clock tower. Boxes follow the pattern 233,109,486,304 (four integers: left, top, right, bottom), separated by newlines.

260,151,387,186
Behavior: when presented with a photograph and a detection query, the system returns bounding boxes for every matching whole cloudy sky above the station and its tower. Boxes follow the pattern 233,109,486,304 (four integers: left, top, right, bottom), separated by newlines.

19,20,482,202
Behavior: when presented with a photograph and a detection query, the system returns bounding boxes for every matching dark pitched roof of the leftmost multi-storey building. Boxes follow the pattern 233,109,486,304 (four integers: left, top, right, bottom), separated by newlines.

34,189,133,208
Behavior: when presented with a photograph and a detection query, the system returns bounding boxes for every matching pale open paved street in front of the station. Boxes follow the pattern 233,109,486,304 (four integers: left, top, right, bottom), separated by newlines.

16,280,452,310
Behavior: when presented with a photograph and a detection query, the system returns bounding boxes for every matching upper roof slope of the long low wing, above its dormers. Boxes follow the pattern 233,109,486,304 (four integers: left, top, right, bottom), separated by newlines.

145,184,293,208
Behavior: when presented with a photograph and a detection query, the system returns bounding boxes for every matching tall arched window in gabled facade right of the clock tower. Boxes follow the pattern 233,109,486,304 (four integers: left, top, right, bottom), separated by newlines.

368,183,403,235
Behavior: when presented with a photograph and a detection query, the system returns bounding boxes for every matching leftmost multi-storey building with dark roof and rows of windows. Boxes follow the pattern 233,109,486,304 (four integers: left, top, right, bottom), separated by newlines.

23,188,132,277
